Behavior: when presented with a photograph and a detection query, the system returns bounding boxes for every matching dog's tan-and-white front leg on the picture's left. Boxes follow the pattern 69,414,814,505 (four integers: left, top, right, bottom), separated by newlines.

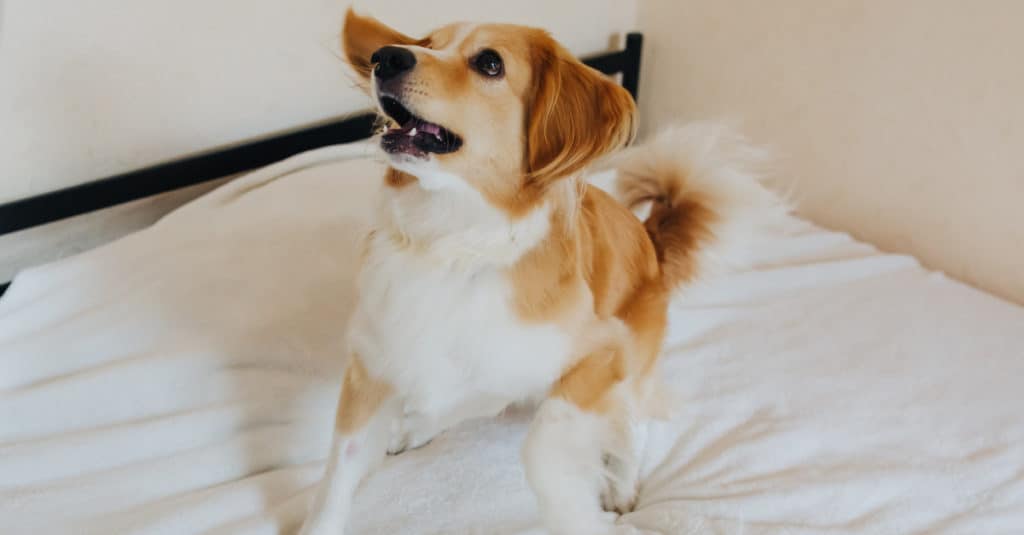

300,355,399,535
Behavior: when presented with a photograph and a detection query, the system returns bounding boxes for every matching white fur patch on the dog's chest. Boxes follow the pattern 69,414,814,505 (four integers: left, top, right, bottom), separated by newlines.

349,183,572,418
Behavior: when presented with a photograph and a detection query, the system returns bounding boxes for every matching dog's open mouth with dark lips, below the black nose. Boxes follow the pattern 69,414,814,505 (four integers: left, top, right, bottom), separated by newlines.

380,96,462,158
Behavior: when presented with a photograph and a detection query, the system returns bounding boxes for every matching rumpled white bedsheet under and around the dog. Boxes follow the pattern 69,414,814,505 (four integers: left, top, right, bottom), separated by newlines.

0,148,1024,535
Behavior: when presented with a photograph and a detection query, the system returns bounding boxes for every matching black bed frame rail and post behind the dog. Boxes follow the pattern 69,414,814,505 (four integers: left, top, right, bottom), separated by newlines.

0,33,643,295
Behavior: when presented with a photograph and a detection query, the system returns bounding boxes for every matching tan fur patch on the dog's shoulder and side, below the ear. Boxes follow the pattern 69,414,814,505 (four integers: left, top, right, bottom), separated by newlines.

511,184,672,412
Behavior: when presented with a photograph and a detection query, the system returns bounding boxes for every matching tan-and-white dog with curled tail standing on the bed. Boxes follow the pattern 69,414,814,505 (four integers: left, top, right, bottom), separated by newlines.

301,9,777,535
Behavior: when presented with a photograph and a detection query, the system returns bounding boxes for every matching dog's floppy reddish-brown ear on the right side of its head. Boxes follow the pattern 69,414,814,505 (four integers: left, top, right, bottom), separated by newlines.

525,34,636,184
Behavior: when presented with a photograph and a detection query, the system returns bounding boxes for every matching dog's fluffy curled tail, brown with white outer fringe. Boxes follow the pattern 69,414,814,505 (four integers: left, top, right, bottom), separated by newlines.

610,122,790,287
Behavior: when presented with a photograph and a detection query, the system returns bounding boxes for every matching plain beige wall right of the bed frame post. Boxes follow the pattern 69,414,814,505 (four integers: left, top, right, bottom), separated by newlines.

638,0,1024,302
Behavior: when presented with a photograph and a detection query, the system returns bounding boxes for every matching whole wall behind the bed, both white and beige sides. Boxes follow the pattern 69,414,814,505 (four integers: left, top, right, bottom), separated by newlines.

6,0,1024,302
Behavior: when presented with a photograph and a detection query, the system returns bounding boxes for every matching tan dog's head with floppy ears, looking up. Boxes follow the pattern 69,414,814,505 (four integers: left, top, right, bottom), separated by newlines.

342,9,635,212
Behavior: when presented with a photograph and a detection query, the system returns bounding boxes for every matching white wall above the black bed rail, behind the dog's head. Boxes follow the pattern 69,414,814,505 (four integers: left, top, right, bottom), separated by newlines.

0,0,636,202
